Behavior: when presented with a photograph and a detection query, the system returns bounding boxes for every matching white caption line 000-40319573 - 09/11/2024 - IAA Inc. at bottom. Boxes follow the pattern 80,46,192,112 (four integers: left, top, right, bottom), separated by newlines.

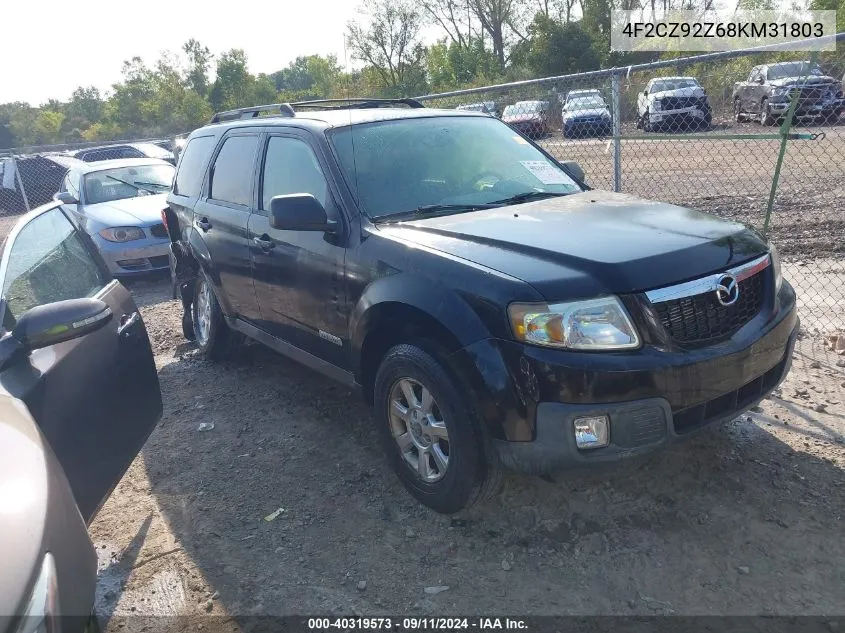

308,617,528,631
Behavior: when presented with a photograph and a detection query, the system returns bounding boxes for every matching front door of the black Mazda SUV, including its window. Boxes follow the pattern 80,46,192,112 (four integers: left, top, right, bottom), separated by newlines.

249,135,349,367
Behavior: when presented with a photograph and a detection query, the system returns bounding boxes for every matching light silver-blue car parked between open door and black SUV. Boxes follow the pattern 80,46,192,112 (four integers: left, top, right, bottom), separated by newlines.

50,158,174,276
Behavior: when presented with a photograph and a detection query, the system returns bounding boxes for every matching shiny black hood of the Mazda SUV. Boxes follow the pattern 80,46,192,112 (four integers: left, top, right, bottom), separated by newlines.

380,191,767,301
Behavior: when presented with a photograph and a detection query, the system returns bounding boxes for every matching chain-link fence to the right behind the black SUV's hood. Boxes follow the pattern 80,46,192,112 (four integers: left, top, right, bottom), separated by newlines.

420,35,845,378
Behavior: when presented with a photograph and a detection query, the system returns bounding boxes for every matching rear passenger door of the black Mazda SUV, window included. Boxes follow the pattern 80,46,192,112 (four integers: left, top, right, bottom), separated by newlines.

193,132,260,321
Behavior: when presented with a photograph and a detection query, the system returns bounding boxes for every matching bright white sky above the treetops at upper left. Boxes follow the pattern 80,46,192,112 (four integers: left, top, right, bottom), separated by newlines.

0,0,366,105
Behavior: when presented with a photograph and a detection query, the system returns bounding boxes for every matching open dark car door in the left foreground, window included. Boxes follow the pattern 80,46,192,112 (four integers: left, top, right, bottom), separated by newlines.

0,206,162,521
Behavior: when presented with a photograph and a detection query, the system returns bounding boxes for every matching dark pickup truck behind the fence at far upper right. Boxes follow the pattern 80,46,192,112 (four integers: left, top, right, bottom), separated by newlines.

733,61,845,125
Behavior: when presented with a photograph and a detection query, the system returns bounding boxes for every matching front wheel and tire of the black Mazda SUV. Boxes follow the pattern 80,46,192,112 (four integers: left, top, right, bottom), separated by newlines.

374,344,501,514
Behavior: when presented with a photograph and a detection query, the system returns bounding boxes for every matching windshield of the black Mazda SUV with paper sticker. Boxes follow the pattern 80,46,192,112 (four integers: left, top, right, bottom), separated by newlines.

329,116,581,219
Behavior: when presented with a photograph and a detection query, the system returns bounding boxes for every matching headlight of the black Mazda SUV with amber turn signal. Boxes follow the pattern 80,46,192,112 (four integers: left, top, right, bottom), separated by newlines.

508,297,640,350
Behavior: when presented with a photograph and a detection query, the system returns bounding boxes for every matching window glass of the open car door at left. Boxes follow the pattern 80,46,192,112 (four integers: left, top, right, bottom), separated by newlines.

3,208,108,329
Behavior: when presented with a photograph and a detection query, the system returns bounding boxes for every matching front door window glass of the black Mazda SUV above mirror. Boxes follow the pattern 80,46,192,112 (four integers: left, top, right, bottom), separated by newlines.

261,136,328,210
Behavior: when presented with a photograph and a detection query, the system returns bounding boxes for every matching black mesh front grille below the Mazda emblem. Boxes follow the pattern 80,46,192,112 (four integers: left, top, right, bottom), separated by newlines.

654,272,763,345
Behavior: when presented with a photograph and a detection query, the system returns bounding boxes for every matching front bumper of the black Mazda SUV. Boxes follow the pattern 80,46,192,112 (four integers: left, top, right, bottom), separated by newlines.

448,282,799,473
